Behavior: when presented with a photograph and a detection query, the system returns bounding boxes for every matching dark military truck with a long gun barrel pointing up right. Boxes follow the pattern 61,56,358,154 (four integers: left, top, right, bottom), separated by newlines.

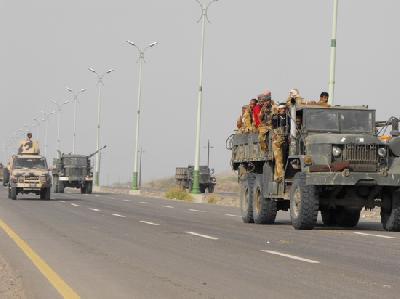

52,146,107,194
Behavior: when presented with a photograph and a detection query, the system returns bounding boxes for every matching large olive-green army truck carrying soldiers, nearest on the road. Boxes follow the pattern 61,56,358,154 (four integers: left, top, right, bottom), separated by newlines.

227,103,400,231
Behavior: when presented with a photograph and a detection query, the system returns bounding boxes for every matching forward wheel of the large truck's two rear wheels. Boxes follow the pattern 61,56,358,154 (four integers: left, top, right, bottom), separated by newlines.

252,175,278,224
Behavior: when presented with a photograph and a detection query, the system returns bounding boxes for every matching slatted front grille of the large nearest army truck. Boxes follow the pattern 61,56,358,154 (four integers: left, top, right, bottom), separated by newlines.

343,144,378,172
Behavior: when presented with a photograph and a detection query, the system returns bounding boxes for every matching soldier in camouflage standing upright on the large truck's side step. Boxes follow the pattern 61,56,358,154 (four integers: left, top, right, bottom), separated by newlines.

272,104,289,182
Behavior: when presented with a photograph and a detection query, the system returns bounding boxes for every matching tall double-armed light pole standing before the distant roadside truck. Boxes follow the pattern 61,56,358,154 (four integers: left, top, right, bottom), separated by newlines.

191,0,218,194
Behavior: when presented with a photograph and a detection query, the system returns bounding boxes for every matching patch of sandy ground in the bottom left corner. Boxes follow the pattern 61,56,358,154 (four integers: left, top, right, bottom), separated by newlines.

0,254,26,299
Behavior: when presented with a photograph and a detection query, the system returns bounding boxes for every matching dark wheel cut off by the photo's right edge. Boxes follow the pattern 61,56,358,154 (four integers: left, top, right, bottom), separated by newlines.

381,191,400,232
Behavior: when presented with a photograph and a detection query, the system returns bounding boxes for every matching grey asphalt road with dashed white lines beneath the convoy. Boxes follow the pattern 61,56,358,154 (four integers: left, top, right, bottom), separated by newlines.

0,189,400,299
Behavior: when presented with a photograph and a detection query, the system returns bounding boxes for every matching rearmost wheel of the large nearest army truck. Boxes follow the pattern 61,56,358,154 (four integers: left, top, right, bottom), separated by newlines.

240,173,255,223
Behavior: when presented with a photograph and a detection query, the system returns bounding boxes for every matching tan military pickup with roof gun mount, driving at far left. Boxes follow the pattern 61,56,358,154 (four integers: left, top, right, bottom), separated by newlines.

6,141,51,200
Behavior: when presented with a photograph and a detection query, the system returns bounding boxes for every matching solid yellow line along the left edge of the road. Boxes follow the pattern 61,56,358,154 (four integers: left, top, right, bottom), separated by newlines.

0,219,80,299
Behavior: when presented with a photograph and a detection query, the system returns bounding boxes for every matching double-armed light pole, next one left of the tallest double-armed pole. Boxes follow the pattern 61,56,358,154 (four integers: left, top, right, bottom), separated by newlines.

126,40,158,191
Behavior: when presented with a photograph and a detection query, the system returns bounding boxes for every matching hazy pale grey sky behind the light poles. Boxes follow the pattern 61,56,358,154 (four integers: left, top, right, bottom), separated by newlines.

0,0,400,183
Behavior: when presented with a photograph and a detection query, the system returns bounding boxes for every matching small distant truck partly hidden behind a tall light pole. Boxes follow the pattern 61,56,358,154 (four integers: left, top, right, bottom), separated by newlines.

175,166,217,193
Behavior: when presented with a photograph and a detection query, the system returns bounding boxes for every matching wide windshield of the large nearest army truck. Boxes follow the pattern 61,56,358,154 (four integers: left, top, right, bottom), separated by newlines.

305,109,374,133
